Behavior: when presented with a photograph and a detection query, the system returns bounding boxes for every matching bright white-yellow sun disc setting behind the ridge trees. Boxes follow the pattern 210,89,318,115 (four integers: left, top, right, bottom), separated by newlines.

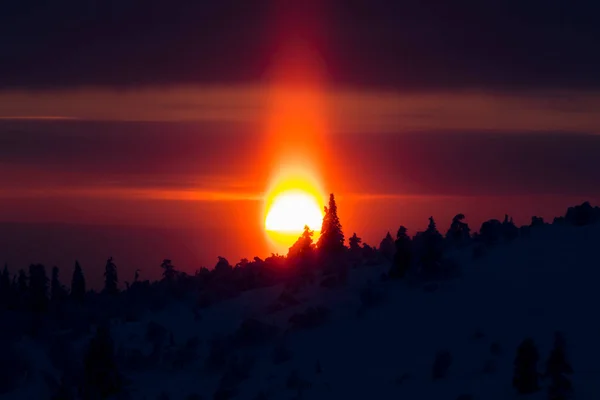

265,189,323,234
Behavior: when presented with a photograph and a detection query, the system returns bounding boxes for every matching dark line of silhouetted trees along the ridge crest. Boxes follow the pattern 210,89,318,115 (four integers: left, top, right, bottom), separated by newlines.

0,198,600,313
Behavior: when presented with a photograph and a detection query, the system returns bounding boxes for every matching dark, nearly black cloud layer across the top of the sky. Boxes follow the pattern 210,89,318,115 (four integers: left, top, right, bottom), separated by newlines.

0,0,600,89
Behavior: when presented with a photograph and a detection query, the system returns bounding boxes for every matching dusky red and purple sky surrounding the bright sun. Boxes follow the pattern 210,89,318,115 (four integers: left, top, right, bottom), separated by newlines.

0,0,600,286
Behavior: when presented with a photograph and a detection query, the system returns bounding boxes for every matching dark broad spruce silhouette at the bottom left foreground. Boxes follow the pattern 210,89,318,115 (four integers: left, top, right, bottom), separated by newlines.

82,325,123,400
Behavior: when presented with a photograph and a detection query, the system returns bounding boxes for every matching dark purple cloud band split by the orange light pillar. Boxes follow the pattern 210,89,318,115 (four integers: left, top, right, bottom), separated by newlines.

0,122,600,196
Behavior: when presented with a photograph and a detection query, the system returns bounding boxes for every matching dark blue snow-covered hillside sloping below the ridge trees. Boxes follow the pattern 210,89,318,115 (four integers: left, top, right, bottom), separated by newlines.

6,225,600,400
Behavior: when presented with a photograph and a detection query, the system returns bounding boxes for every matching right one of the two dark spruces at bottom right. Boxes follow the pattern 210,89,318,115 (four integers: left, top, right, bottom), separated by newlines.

544,332,573,400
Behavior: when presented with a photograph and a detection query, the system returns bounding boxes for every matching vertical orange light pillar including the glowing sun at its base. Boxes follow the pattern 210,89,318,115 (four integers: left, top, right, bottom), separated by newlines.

263,25,328,253
